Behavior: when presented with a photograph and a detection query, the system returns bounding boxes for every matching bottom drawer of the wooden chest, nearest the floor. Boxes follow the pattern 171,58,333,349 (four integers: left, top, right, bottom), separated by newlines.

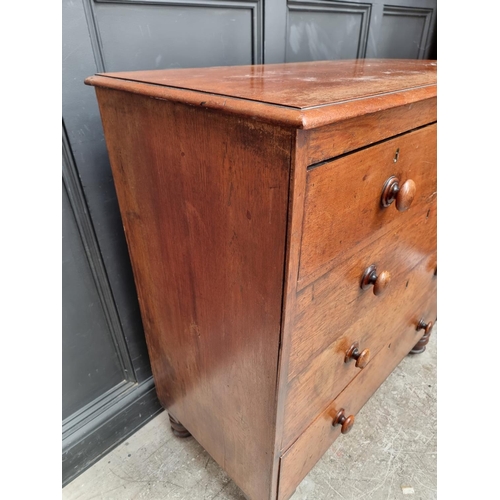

278,298,436,500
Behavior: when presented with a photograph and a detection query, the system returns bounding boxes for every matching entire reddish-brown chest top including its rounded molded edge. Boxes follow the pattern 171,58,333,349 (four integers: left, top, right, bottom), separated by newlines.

85,59,437,128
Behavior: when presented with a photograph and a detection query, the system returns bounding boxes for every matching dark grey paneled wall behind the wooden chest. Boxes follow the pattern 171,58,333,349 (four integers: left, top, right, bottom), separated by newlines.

62,0,436,483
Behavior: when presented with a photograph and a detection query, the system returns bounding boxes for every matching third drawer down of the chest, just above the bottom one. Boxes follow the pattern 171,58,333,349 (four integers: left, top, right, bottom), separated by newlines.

283,255,437,447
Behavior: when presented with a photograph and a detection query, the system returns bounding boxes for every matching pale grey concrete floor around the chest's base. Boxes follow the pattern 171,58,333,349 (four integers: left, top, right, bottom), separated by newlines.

62,328,437,500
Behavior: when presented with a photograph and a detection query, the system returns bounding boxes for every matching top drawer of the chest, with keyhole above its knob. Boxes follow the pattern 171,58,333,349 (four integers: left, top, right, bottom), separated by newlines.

298,124,436,288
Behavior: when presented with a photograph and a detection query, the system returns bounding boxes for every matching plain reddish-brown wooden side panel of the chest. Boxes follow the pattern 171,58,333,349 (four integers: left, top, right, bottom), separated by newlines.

96,89,292,500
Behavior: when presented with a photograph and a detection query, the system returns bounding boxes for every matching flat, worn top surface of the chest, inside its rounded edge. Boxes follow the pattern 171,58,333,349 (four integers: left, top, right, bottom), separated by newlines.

94,59,437,108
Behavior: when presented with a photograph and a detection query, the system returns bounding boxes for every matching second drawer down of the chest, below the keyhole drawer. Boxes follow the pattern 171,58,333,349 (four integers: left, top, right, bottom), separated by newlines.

288,202,437,380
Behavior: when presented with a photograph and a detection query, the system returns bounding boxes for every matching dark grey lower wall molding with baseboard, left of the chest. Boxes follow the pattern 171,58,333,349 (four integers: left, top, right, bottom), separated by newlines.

62,122,161,485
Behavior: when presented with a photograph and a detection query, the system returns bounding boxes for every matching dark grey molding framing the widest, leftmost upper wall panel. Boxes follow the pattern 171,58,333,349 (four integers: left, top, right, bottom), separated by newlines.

88,0,264,67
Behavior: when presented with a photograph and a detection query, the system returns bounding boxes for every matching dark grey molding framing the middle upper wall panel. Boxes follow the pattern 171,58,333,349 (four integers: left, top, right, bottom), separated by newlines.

286,0,372,59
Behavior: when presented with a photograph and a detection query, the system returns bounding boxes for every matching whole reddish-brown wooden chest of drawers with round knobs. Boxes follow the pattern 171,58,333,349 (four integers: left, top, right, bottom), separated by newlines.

86,60,437,500
